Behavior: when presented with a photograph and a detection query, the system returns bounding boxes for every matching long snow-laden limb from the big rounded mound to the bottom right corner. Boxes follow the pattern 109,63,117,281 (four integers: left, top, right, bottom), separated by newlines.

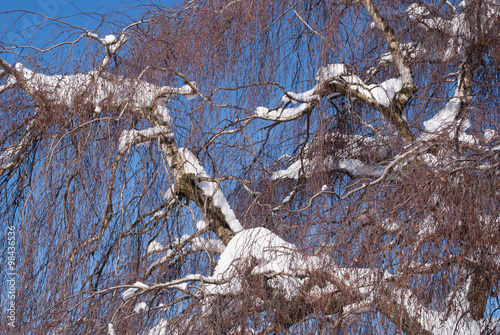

204,228,498,335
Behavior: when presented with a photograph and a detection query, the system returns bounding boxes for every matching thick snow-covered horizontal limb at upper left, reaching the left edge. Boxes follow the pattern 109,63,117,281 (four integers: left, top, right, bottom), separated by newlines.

1,60,196,112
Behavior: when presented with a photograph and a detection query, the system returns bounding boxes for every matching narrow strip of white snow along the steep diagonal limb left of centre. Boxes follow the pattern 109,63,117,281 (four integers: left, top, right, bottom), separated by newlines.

179,148,243,233
